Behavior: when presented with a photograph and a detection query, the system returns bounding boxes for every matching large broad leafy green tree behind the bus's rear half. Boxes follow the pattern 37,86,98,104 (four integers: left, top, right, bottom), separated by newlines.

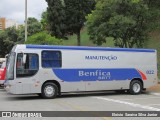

87,0,154,48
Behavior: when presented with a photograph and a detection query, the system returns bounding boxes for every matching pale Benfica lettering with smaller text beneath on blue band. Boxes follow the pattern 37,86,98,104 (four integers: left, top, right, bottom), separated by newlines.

78,70,111,80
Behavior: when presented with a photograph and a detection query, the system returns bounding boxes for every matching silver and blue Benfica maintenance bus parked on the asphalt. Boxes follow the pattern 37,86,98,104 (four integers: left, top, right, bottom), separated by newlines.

5,45,158,99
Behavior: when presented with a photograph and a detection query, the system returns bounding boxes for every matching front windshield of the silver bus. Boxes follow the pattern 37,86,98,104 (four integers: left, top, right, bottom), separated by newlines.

6,52,16,80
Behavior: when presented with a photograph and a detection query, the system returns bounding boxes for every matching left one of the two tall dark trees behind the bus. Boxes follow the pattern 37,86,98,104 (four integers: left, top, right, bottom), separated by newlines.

46,0,66,38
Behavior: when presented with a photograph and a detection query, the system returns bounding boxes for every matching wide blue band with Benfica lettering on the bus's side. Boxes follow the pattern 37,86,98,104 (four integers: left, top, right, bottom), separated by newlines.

52,68,142,82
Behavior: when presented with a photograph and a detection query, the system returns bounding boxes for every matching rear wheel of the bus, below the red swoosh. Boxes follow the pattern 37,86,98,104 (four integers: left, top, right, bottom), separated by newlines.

129,80,142,95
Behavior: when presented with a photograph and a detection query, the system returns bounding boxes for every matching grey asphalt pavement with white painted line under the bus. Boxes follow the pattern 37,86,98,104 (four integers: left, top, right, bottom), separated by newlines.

0,89,160,120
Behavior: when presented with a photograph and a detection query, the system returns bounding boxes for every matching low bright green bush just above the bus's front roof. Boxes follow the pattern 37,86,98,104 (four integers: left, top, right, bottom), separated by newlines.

25,31,62,45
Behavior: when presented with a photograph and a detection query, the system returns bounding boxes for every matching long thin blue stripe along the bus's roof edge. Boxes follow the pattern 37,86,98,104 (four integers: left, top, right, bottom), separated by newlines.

26,45,156,52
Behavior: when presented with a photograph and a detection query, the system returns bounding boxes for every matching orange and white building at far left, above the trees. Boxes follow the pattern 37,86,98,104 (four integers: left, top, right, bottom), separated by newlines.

0,18,18,30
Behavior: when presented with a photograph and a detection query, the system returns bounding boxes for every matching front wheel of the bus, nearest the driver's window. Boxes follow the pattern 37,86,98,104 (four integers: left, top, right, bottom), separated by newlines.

42,82,58,99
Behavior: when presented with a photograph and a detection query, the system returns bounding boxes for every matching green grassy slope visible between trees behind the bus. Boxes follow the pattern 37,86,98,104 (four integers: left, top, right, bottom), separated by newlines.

63,28,160,78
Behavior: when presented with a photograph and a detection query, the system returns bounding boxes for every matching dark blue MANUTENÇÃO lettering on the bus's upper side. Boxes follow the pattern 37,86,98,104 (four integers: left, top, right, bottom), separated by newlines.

85,55,117,61
